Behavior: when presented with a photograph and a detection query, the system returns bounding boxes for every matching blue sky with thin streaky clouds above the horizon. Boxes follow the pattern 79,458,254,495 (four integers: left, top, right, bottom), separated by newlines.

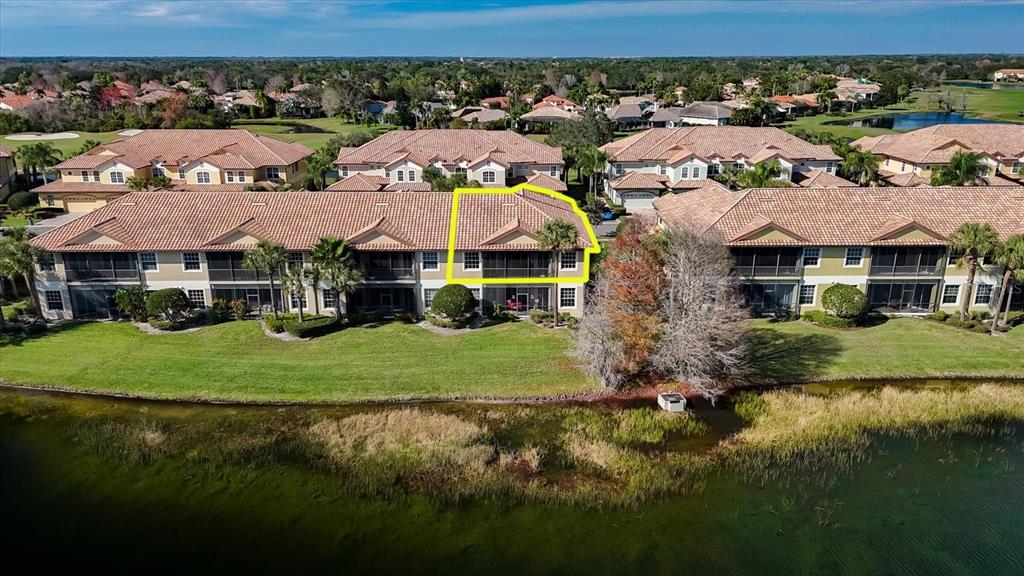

0,0,1024,57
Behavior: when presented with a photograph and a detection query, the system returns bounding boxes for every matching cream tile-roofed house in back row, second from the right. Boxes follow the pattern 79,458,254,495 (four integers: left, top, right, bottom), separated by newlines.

601,126,840,210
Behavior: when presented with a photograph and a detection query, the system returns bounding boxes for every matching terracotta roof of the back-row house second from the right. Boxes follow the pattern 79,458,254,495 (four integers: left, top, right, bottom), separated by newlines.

601,126,840,162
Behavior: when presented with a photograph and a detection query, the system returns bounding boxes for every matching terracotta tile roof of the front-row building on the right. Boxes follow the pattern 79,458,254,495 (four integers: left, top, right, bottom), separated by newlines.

654,187,1024,246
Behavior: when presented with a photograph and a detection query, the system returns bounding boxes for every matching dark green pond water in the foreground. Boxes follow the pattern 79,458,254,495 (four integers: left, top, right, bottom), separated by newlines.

0,390,1024,576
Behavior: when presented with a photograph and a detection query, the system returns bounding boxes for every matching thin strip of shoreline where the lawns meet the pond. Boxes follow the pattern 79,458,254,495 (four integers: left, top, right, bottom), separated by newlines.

0,374,1024,408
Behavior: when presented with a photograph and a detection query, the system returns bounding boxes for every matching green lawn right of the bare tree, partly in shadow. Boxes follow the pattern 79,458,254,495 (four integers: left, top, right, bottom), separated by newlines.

754,318,1024,381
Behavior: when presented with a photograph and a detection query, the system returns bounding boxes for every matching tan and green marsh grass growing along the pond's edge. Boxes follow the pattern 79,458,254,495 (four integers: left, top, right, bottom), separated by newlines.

16,383,1024,508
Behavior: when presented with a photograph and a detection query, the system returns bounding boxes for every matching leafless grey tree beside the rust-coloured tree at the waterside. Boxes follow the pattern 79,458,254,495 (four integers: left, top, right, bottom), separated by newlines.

651,233,750,402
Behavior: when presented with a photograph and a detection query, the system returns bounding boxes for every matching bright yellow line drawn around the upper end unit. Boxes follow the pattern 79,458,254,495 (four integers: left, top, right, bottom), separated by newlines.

444,183,601,285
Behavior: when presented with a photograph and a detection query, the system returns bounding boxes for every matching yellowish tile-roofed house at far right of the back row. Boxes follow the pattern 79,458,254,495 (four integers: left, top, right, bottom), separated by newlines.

853,123,1024,187
